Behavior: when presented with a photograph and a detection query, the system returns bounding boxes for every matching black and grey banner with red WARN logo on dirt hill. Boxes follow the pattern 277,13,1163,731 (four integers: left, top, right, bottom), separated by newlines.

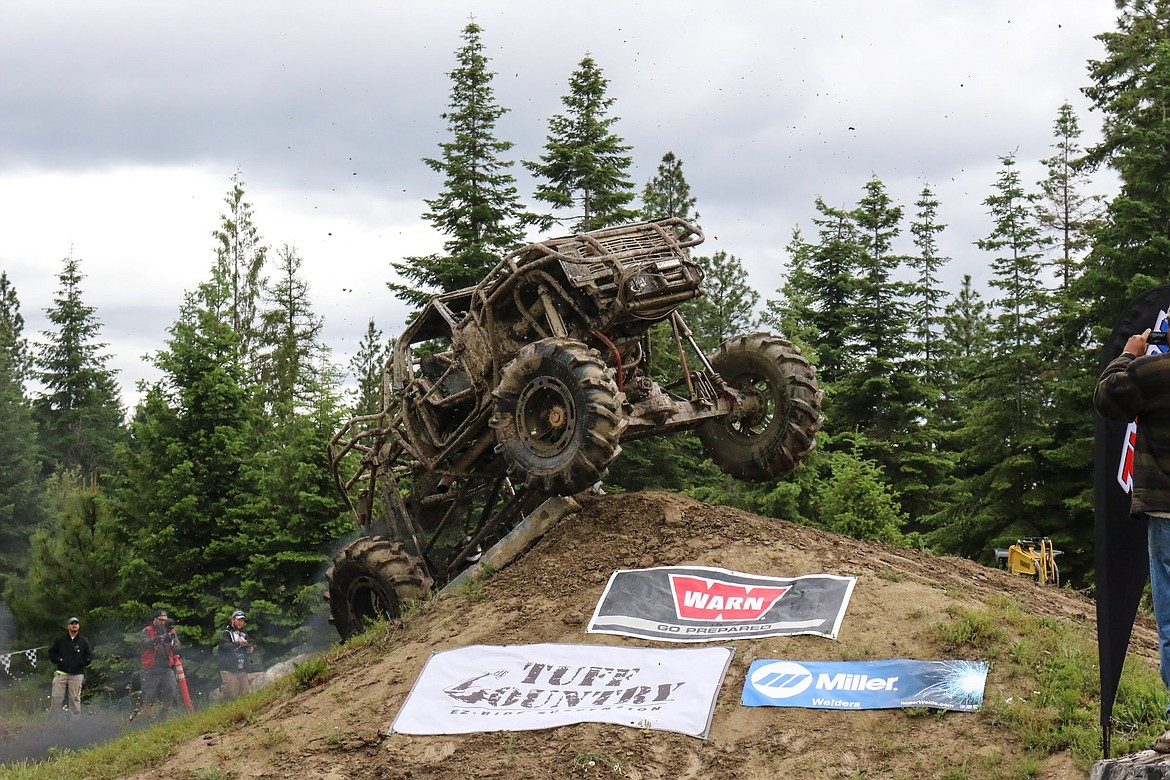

586,566,856,642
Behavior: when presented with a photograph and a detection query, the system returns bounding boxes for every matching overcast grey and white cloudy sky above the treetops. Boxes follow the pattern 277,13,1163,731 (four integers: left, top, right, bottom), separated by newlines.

0,0,1116,402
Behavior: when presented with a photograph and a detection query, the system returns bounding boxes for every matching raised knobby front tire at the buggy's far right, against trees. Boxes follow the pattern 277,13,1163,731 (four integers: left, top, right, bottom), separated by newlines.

698,333,821,481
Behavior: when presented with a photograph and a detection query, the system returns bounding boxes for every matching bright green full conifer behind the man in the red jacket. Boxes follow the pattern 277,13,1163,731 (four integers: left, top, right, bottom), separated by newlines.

117,283,257,640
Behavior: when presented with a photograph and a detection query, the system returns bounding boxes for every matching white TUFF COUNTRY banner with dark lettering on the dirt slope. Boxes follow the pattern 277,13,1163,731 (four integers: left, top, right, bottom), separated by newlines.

390,644,732,739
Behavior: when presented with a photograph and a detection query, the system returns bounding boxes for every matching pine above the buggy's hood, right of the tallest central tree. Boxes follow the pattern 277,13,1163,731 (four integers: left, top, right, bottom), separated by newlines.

524,55,638,232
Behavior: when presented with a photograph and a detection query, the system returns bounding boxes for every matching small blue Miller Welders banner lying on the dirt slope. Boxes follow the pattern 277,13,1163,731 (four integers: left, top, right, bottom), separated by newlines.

741,658,987,712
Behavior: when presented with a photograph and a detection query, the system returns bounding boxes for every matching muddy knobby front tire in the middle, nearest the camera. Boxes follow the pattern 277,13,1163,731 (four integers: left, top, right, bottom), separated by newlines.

491,338,626,496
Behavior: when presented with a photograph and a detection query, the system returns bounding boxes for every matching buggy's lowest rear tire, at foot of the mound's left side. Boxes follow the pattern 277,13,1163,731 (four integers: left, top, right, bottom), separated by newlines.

325,537,433,640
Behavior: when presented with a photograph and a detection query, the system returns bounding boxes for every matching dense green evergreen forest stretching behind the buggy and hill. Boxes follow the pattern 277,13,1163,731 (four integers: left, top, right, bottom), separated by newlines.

0,6,1170,696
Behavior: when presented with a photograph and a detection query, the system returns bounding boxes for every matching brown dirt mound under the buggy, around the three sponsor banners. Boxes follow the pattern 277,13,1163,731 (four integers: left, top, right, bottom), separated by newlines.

125,492,1155,780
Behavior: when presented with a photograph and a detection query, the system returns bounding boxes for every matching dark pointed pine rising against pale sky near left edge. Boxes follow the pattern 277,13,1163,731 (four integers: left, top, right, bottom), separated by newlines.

33,257,124,478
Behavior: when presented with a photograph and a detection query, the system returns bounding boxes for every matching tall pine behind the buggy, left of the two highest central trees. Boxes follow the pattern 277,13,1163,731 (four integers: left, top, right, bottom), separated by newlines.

388,22,537,306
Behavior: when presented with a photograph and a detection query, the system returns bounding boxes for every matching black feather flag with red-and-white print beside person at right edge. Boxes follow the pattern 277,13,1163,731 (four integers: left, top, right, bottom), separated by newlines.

1093,285,1170,758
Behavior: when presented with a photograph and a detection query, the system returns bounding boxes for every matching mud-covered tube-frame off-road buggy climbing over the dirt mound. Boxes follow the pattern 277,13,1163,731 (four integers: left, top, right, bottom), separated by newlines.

325,219,821,637
